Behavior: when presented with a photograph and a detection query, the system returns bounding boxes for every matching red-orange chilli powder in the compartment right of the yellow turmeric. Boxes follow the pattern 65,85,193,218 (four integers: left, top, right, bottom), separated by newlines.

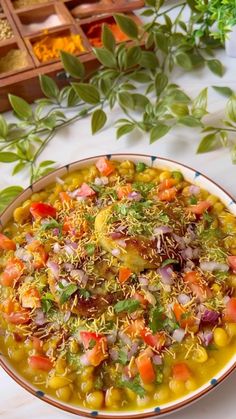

86,22,129,47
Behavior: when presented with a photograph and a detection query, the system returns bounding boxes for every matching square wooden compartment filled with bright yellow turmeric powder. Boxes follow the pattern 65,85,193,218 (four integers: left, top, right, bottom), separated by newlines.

25,25,91,67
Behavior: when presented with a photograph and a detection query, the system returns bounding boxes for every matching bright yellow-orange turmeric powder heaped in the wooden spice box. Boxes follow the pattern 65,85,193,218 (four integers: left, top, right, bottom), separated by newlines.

33,34,85,63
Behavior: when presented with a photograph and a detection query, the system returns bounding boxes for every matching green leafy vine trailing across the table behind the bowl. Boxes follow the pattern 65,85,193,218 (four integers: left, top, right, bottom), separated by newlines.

0,0,235,210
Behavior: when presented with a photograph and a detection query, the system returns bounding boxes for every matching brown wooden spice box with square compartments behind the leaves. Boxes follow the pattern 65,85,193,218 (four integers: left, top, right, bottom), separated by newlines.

0,0,144,112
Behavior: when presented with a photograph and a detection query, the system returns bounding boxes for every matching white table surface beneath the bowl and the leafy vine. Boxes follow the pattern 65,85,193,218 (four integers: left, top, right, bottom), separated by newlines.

0,4,236,419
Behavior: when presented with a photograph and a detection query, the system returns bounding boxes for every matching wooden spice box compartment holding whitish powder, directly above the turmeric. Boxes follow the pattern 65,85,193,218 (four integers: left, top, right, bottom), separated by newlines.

14,2,73,36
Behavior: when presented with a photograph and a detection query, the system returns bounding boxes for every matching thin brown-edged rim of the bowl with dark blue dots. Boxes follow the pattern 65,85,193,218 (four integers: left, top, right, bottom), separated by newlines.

0,153,236,419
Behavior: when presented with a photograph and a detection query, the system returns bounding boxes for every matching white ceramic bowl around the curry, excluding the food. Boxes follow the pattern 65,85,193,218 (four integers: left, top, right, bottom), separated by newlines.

0,154,236,419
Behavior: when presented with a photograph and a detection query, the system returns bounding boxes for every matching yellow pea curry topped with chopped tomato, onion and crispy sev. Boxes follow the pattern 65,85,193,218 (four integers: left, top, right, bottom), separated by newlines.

0,158,236,410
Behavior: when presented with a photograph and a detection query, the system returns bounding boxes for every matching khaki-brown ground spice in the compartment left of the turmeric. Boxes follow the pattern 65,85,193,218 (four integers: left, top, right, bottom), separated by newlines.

0,49,28,74
